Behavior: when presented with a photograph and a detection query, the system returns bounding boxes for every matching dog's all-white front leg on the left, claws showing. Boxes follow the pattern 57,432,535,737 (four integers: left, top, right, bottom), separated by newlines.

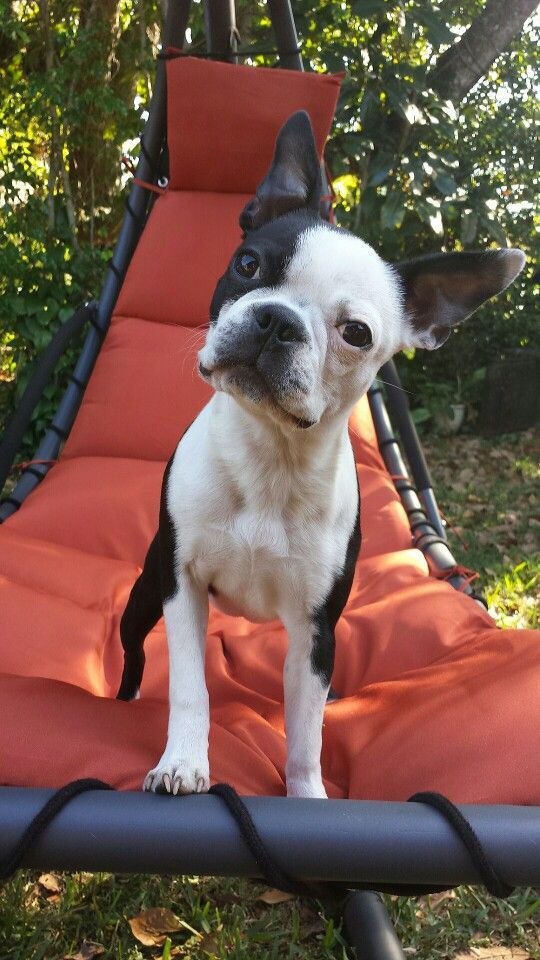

144,571,210,794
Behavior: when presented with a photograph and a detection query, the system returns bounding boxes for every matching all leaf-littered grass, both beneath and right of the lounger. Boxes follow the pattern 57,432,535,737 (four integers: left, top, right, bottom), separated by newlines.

0,431,540,960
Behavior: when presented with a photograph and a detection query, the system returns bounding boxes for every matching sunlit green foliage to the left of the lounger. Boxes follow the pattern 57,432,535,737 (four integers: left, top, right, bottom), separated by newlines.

0,0,158,456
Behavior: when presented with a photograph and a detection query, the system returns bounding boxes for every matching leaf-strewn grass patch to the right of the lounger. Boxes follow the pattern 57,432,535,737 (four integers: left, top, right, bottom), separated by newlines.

424,429,540,628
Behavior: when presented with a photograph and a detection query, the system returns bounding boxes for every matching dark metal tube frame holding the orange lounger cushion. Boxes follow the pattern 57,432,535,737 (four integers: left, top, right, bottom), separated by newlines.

0,0,540,960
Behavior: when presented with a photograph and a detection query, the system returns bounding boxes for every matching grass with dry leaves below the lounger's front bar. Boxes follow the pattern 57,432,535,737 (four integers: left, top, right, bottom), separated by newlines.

0,871,540,960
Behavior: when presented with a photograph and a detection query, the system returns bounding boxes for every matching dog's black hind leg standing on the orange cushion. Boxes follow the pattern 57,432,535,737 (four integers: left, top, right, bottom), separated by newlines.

116,534,163,700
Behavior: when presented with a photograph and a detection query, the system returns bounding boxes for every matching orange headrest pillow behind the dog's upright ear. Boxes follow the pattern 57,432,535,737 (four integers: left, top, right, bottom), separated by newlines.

167,57,342,194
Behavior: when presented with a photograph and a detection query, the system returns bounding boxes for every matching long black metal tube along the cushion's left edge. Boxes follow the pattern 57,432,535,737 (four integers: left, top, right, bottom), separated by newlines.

0,0,191,521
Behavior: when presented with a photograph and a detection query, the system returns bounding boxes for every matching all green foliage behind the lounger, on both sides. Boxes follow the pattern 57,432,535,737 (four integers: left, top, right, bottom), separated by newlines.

0,0,540,458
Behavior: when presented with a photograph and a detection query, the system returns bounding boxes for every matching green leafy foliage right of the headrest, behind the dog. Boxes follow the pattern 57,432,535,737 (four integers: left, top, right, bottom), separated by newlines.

292,0,540,406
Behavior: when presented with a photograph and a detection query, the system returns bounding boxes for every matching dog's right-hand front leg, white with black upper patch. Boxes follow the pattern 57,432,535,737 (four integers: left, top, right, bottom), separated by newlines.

283,620,334,797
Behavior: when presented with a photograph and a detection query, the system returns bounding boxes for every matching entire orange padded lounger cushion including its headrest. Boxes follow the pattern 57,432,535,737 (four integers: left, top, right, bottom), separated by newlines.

0,60,540,803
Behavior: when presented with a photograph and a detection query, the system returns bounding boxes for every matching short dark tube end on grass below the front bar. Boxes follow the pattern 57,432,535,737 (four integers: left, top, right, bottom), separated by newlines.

343,890,405,960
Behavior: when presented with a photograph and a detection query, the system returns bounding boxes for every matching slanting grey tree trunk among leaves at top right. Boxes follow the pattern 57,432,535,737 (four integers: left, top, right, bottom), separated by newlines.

430,0,538,104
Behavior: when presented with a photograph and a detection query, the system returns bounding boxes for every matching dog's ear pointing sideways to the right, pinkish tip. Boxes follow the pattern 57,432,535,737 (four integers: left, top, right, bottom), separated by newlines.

396,249,525,350
